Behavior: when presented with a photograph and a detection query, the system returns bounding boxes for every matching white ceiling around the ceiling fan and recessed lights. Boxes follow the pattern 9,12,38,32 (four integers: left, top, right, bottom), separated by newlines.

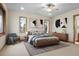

6,3,79,17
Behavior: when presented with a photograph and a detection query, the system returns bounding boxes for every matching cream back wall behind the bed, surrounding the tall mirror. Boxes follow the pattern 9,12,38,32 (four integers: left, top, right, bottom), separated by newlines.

9,11,51,34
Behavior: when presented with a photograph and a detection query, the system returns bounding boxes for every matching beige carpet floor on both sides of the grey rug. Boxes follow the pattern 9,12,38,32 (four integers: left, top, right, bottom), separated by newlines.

0,42,79,56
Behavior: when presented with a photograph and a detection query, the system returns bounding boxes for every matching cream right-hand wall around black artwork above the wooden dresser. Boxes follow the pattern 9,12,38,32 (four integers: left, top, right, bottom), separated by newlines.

52,9,79,42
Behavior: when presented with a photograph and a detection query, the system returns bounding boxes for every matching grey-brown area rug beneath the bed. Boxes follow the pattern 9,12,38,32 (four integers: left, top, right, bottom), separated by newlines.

24,42,70,56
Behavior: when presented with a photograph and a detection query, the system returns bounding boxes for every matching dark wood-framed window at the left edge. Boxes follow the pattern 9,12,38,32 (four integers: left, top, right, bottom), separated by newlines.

0,4,5,36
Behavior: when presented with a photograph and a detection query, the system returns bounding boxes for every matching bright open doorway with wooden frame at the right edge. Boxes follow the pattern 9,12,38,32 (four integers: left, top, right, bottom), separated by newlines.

73,14,79,44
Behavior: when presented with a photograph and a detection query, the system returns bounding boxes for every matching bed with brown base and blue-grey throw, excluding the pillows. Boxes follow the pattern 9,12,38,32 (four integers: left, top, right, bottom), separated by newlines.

28,34,59,47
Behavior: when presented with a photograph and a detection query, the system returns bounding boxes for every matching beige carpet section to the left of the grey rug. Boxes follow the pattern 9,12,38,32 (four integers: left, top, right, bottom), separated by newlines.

0,42,29,56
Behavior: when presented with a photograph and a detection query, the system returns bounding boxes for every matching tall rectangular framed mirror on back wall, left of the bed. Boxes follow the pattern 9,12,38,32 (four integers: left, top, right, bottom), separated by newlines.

19,16,27,33
